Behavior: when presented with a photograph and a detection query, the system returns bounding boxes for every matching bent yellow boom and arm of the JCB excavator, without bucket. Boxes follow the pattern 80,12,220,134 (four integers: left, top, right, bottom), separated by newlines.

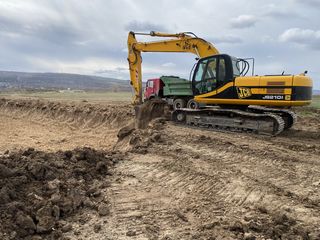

128,32,219,104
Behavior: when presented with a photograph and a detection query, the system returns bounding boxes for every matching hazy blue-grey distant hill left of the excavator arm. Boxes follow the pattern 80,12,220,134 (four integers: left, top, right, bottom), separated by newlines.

0,71,131,91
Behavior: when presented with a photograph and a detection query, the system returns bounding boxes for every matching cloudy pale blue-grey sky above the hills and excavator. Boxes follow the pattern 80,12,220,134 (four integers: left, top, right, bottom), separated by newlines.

0,0,320,89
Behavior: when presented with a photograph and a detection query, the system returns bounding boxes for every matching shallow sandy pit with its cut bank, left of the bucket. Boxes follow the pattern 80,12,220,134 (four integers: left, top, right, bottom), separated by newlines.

0,99,134,152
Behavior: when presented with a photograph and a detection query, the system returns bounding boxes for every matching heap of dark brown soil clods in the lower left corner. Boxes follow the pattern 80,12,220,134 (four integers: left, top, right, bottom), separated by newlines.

0,148,123,239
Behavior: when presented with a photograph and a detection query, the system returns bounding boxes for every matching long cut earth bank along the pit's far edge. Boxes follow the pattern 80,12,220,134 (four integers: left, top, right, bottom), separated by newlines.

0,99,134,128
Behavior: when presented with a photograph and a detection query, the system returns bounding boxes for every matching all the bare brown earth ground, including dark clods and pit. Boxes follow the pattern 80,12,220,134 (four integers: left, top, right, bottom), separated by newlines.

0,97,320,240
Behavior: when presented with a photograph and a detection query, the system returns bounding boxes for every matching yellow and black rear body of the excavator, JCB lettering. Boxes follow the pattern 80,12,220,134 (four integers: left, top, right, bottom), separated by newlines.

194,75,312,106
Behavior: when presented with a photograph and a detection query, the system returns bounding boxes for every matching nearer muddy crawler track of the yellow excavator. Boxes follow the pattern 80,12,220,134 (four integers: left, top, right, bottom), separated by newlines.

172,108,285,136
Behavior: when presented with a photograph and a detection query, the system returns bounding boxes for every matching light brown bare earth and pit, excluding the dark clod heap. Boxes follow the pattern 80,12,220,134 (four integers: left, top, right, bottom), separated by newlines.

0,100,320,239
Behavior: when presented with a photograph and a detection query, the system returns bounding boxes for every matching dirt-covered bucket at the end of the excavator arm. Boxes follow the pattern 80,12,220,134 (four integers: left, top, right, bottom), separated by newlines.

135,99,170,129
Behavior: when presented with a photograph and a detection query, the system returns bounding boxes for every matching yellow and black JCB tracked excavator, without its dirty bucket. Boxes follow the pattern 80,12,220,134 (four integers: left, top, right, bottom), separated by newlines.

128,32,312,135
